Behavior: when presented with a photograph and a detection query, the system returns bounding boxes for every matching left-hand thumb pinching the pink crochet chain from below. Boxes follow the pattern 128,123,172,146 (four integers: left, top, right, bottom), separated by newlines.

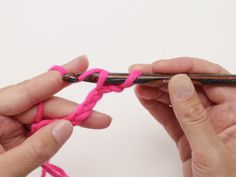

0,120,73,177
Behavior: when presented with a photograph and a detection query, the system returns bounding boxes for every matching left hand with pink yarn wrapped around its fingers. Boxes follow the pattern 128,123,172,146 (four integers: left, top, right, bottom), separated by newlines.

0,56,111,177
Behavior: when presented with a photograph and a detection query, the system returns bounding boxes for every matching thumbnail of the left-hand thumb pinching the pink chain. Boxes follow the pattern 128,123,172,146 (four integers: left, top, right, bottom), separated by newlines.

52,120,73,145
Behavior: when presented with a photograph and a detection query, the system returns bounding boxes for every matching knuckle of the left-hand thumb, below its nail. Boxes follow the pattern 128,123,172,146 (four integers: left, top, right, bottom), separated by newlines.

29,140,51,163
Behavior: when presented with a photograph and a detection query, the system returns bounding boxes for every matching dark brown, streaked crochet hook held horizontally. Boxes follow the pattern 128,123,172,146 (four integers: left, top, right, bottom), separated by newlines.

62,73,236,85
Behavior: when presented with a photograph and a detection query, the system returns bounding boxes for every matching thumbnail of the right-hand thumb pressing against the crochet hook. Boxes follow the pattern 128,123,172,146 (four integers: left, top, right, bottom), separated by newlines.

172,74,194,101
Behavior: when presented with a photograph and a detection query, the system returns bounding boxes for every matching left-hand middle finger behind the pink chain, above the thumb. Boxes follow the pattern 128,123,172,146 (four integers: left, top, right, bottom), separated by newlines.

15,97,111,129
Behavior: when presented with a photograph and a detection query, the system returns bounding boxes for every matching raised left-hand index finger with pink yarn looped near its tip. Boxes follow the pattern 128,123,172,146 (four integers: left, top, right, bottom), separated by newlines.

0,56,88,116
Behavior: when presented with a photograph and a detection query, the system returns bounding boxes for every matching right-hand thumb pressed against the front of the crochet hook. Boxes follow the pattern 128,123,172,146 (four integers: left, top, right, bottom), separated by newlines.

168,74,220,152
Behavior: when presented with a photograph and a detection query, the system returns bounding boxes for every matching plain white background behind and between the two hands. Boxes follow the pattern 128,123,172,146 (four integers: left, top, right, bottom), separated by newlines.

0,0,236,177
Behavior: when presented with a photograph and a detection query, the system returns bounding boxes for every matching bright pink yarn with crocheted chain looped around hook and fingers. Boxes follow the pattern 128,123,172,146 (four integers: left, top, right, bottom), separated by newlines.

30,66,141,177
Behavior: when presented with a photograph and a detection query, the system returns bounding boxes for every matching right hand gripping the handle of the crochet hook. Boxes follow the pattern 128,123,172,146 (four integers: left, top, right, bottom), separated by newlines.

131,58,236,177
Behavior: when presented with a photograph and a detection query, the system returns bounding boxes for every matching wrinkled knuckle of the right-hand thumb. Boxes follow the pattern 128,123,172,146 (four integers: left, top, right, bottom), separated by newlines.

183,105,207,125
